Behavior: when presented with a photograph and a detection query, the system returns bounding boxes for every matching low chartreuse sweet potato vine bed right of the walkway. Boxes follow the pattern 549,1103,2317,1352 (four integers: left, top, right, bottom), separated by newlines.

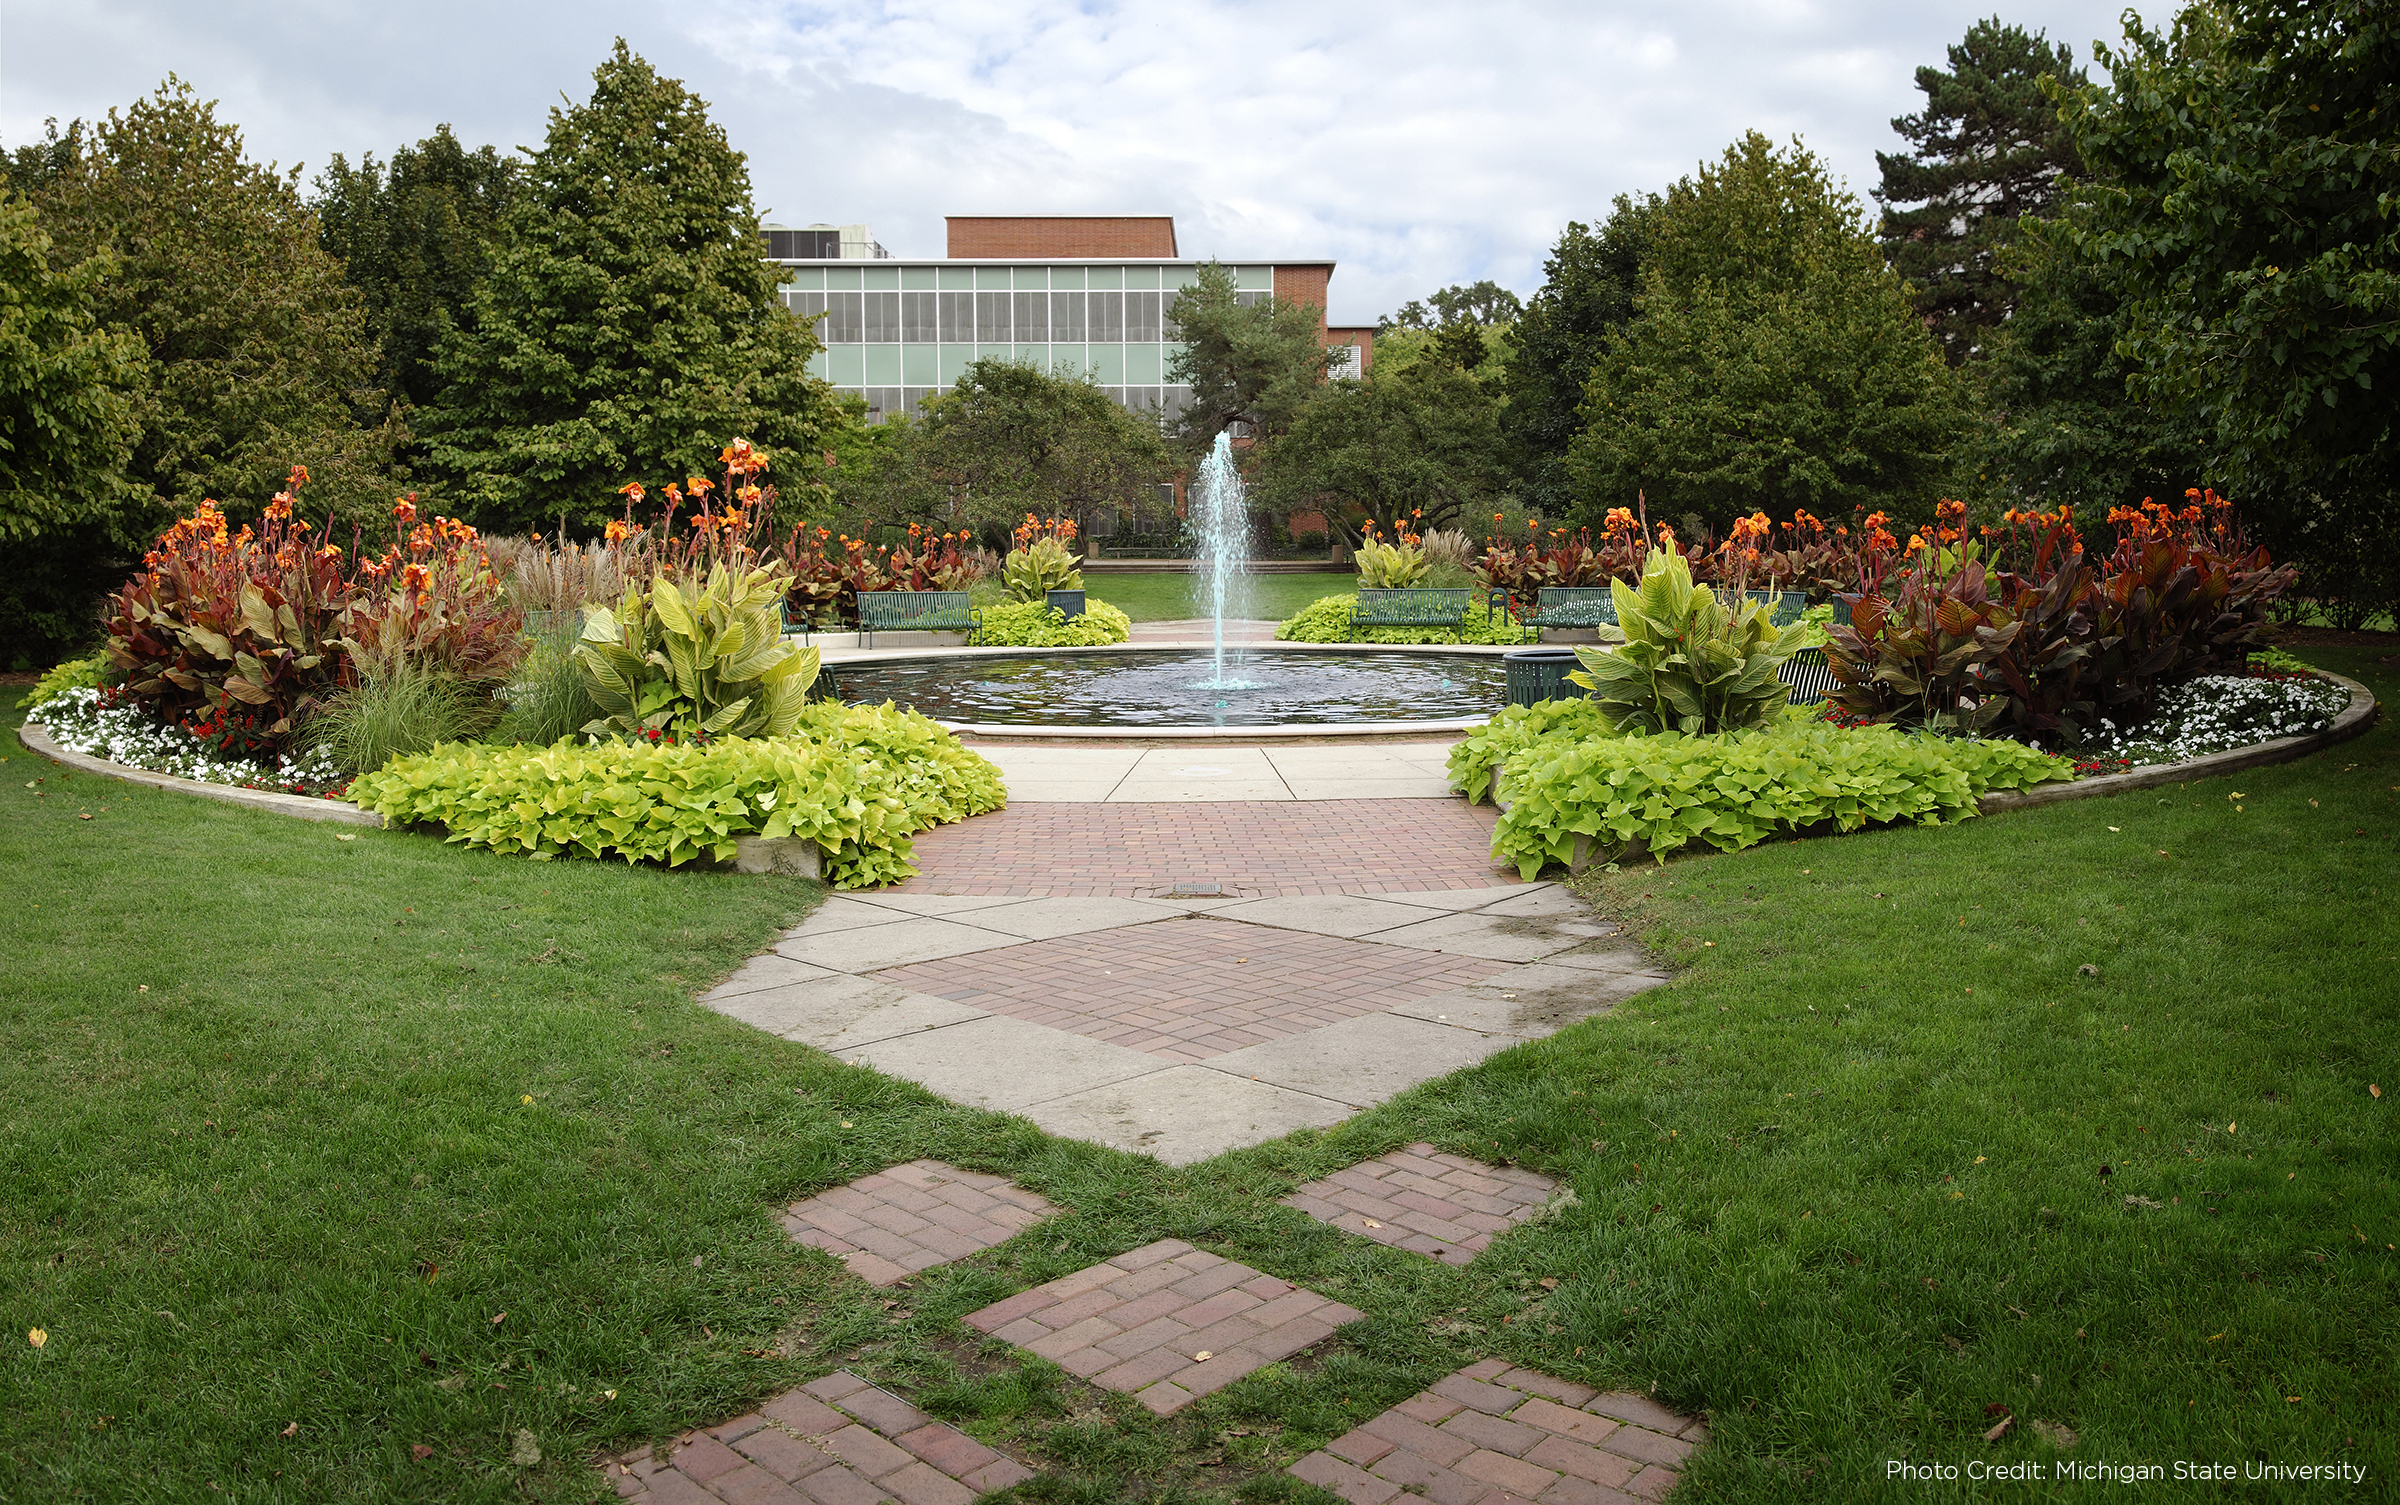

1450,701,2074,879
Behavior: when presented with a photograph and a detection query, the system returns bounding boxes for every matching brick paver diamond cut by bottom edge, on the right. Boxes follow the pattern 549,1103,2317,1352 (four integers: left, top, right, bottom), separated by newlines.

1289,1359,1706,1505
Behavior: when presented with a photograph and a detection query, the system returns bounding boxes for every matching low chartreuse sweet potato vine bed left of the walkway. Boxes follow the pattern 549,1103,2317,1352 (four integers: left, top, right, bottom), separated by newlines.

350,703,1008,888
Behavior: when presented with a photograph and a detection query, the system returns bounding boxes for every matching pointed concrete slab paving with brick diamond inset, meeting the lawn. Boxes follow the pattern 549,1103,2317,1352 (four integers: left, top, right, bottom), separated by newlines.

703,883,1661,1164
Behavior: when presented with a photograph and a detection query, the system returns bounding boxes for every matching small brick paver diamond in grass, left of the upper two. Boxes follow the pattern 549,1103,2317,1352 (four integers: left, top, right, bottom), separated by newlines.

782,1159,1056,1287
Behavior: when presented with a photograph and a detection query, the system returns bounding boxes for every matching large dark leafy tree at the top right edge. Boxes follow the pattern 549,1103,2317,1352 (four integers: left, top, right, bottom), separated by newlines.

2062,0,2400,532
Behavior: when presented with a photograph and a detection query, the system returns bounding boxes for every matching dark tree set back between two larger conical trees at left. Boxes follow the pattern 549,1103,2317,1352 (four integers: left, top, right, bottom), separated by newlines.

312,125,518,406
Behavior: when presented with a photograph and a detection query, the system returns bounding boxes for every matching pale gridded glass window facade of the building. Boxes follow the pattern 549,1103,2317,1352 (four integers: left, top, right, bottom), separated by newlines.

778,257,1274,422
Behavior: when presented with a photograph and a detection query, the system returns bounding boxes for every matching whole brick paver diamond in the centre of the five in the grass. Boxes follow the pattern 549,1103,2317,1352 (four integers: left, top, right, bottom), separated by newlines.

967,1239,1358,1416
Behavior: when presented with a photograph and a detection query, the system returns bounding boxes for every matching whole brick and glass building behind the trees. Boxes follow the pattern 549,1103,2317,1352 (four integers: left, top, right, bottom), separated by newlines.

766,214,1375,422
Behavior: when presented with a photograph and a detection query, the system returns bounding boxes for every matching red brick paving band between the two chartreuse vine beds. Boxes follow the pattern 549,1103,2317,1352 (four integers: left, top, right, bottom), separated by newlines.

898,799,1517,898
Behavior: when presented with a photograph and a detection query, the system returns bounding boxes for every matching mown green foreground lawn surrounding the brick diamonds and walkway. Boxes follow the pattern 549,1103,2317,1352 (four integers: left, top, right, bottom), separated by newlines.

0,652,2400,1505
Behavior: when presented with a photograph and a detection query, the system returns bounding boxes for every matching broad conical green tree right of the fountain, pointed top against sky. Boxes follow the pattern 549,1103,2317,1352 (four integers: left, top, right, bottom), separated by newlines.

1570,132,1963,528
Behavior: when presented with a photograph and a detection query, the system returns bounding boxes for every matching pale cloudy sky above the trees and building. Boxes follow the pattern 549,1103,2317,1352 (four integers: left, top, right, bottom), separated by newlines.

0,0,2172,322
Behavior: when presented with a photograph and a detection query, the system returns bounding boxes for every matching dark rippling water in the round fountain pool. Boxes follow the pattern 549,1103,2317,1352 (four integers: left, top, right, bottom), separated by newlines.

826,648,1507,732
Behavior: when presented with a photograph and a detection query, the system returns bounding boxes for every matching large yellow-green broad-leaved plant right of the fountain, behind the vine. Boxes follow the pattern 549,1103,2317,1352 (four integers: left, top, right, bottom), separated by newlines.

1567,550,1805,737
